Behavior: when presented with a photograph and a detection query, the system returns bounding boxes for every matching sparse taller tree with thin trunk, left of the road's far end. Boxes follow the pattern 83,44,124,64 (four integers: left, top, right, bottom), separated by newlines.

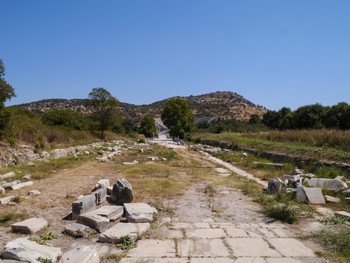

89,88,119,139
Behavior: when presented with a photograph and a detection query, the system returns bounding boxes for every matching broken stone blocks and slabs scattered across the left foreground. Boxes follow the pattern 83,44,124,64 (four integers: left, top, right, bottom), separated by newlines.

0,179,158,263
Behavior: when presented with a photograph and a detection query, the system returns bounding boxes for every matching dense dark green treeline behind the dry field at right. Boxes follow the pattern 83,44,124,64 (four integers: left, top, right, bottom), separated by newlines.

262,102,350,130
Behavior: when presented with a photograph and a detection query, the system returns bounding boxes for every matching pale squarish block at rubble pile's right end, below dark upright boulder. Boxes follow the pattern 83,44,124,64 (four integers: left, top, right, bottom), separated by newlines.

124,203,158,223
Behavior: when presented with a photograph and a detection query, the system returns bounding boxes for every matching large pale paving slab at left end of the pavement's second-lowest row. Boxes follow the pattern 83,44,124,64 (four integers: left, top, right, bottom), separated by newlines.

128,239,176,258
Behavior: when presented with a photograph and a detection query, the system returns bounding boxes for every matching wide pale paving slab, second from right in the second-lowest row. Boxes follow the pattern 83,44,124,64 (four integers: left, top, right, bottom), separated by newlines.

226,238,281,257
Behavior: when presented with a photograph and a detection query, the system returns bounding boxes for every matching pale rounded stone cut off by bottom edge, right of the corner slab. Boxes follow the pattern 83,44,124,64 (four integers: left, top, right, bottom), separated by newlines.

59,246,100,263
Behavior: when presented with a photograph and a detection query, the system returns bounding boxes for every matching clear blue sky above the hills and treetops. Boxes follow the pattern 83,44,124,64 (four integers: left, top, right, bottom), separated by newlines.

0,0,350,110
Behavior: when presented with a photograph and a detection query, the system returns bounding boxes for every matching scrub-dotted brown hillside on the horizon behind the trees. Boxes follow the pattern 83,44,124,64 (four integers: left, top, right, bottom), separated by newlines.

18,91,266,120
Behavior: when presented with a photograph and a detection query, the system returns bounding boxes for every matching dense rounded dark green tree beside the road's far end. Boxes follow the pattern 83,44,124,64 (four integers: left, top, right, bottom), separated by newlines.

161,98,195,139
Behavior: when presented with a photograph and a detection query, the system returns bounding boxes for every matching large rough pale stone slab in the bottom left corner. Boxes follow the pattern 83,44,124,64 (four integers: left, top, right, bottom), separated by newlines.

2,238,62,263
